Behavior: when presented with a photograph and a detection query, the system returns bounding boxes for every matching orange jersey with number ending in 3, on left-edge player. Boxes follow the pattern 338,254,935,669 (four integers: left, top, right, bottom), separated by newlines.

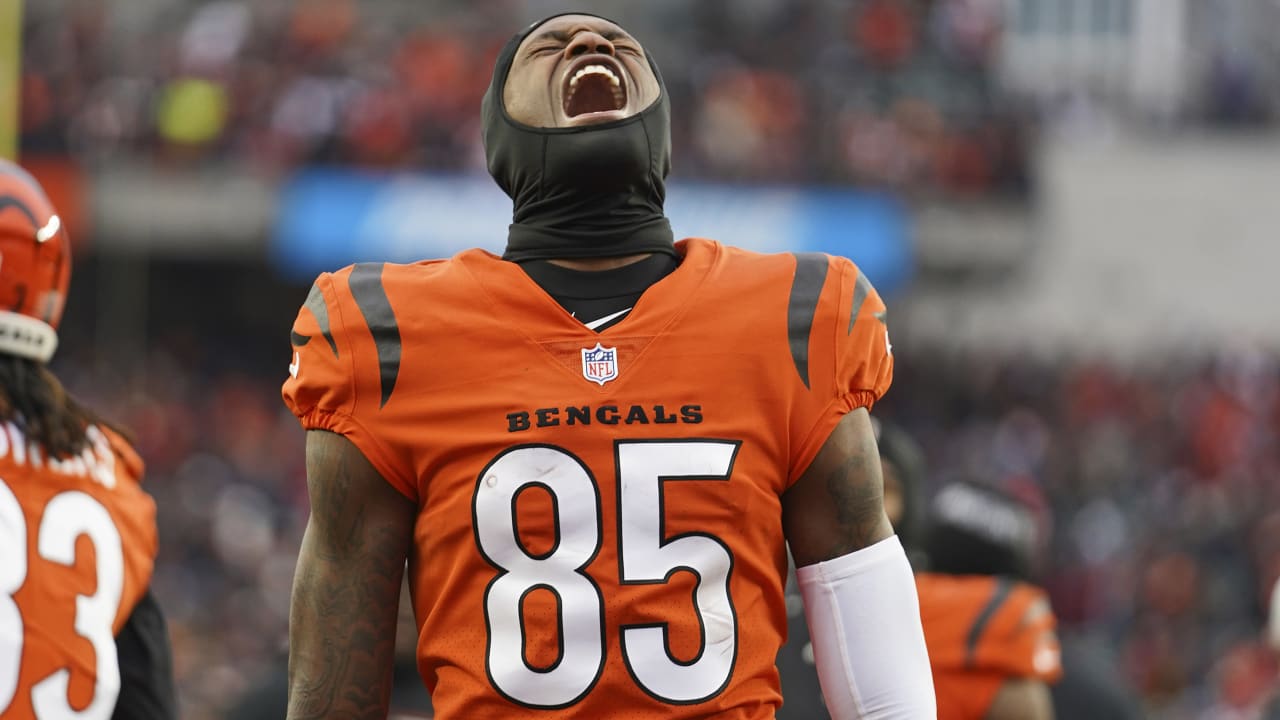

0,424,156,720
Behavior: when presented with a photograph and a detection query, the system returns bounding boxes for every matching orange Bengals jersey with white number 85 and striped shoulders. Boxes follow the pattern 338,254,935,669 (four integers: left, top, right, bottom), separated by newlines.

283,240,892,720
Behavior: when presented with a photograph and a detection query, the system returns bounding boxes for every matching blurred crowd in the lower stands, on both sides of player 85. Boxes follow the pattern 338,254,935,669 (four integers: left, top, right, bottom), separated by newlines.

47,335,1280,720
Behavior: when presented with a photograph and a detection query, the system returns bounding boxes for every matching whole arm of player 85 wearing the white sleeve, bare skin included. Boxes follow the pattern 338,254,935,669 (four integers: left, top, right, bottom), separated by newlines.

782,407,937,720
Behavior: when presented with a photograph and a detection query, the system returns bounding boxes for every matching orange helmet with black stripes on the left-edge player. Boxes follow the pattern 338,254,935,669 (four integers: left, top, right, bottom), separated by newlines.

0,160,72,363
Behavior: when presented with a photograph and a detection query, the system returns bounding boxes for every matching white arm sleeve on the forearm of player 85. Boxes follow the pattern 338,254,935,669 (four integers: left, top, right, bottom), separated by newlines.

796,536,937,720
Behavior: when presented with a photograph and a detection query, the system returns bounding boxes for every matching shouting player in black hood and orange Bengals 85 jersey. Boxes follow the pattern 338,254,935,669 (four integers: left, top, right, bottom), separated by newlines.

283,14,934,720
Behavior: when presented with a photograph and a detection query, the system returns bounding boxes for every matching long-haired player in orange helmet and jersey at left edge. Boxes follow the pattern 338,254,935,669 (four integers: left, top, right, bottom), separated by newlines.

0,160,177,720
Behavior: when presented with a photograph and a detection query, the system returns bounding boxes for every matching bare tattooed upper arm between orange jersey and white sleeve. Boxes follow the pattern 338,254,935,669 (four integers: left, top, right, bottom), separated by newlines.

782,407,893,566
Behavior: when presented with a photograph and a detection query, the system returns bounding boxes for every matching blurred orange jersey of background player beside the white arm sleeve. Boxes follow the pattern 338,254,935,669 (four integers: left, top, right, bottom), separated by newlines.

915,573,1062,720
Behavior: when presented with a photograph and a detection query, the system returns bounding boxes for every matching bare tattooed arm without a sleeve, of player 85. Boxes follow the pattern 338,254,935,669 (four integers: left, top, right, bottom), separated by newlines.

288,430,417,720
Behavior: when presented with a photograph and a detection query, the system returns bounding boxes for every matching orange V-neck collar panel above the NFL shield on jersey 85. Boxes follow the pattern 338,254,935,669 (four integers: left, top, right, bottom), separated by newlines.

457,240,719,341
